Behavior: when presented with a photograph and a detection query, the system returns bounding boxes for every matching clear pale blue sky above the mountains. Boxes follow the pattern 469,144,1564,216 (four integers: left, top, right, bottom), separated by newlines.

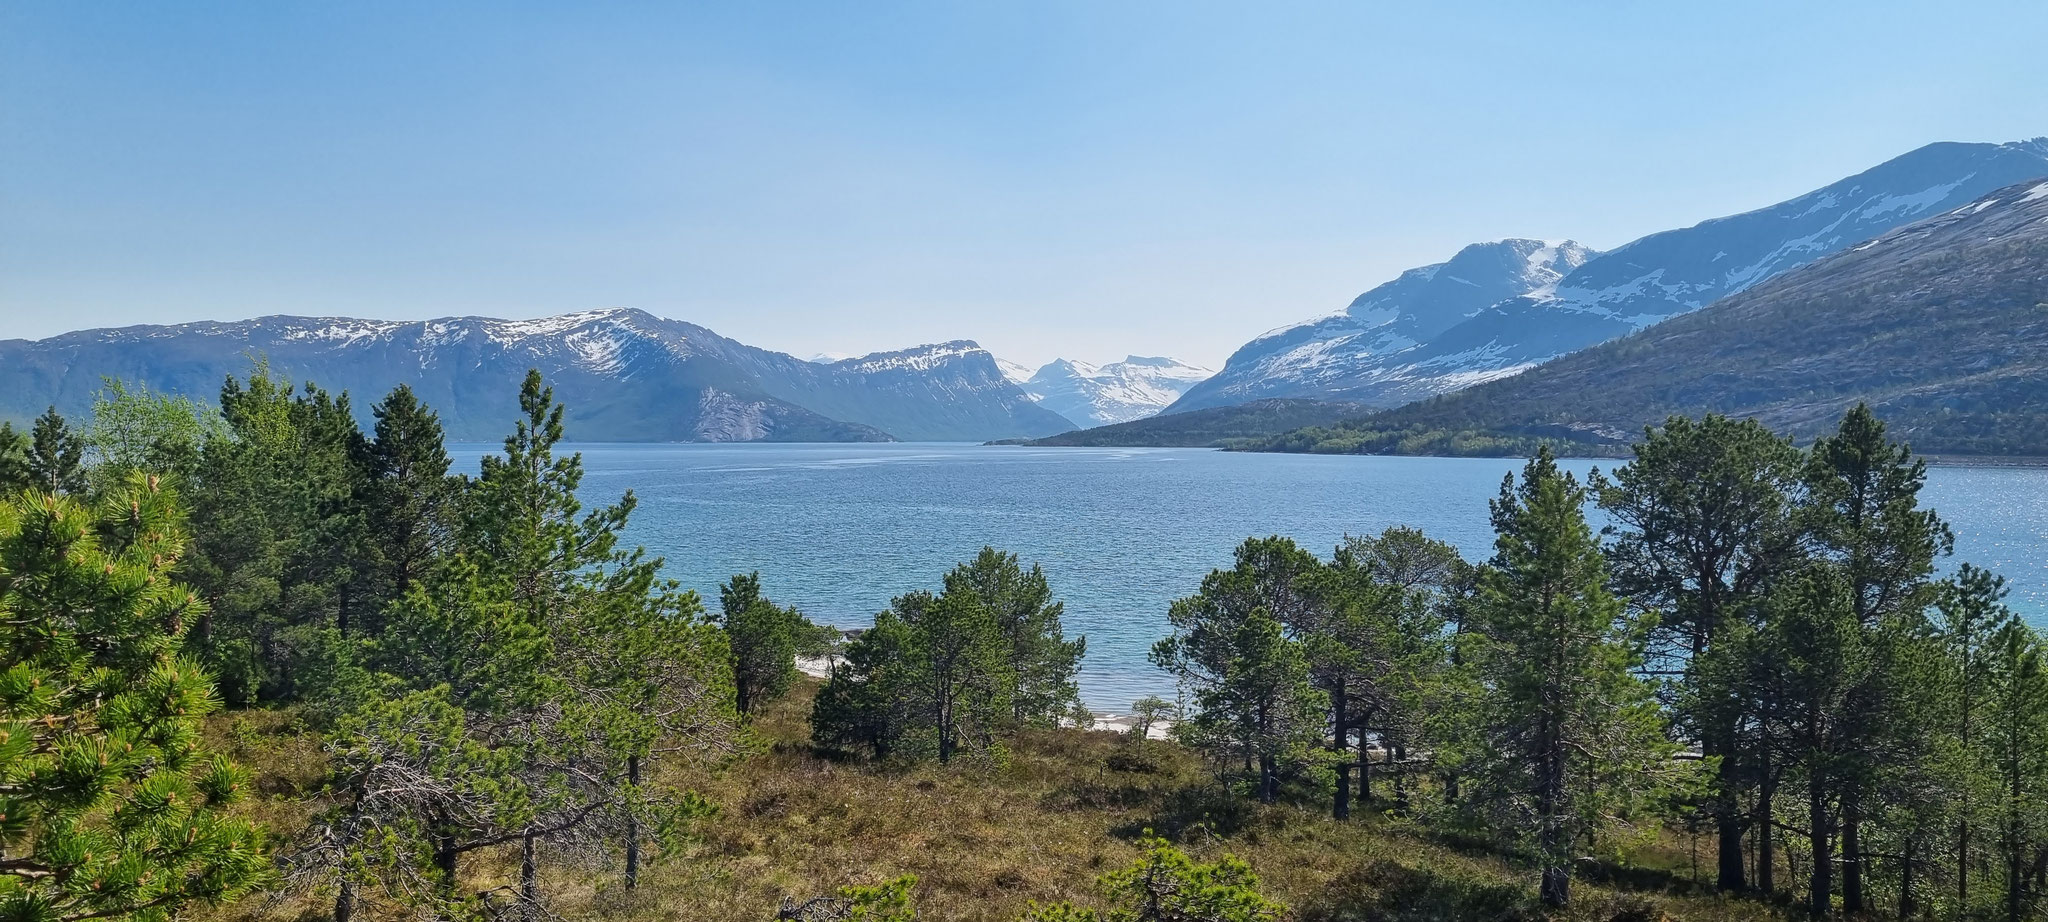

0,0,2048,367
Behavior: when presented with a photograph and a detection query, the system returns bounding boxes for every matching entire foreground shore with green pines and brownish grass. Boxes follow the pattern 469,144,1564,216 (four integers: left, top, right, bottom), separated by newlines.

0,365,2048,922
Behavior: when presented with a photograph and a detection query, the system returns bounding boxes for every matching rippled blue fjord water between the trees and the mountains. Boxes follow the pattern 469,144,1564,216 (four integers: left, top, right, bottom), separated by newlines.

455,443,2048,709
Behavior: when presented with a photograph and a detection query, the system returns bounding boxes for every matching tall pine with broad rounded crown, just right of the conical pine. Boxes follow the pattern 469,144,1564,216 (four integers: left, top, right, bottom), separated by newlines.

1593,414,1800,891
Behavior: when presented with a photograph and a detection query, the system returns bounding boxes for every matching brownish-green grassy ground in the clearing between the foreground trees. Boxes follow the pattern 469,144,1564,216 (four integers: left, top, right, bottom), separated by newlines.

199,686,1782,922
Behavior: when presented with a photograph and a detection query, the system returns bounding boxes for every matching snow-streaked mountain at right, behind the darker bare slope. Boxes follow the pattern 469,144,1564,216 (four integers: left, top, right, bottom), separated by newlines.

1167,139,2048,412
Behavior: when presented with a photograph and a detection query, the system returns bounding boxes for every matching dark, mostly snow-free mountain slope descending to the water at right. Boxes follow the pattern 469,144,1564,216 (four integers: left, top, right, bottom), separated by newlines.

1268,180,2048,455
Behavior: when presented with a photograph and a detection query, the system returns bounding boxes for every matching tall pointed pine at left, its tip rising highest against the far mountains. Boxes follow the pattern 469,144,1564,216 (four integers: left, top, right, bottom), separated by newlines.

459,371,731,908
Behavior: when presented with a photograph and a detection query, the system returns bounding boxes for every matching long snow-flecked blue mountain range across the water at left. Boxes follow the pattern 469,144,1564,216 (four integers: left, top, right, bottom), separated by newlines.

0,309,1073,441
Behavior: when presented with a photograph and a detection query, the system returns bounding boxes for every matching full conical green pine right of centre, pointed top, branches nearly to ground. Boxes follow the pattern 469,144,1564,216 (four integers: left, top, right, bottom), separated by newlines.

1452,451,1675,906
